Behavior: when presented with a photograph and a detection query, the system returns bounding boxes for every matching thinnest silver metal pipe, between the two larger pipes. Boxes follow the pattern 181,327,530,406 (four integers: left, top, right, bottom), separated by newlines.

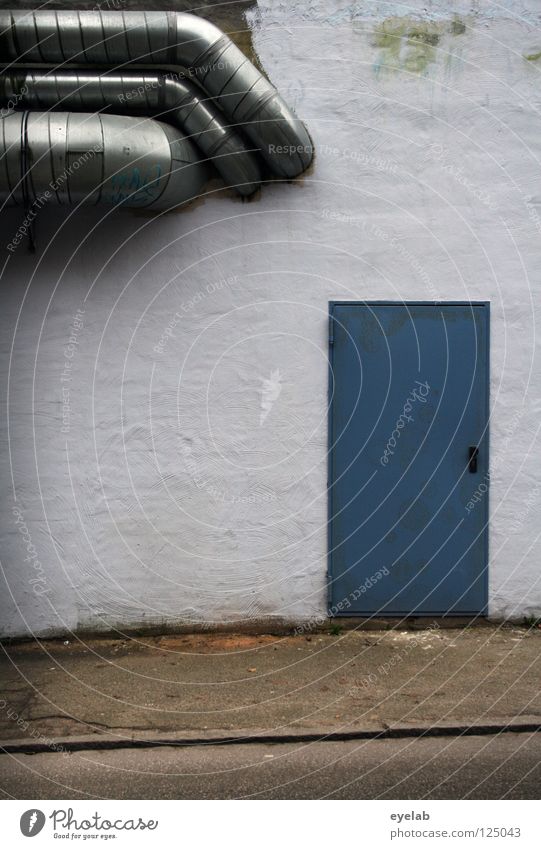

0,70,261,196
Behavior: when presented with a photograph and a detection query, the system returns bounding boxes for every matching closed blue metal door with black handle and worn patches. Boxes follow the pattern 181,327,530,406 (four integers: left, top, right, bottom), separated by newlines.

329,302,489,616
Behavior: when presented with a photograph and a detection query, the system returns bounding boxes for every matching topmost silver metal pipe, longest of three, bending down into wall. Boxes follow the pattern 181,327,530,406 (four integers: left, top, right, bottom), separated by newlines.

0,10,313,178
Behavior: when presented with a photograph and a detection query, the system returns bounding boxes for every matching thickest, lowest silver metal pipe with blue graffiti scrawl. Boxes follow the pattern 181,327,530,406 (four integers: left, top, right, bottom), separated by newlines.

0,112,209,209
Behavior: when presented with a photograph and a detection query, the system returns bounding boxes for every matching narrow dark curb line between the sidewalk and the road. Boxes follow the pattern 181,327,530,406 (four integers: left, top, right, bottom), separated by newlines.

0,721,541,755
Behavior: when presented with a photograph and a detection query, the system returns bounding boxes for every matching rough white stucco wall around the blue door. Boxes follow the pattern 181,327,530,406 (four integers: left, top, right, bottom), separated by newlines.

1,0,541,635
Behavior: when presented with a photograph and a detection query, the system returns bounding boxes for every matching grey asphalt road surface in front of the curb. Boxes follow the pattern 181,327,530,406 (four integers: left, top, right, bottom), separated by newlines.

0,733,541,799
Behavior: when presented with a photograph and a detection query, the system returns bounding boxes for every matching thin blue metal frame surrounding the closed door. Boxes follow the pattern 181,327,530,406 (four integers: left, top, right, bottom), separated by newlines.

327,300,491,619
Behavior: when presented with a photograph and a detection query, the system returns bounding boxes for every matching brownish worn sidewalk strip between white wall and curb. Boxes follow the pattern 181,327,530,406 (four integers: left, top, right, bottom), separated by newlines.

0,623,541,749
